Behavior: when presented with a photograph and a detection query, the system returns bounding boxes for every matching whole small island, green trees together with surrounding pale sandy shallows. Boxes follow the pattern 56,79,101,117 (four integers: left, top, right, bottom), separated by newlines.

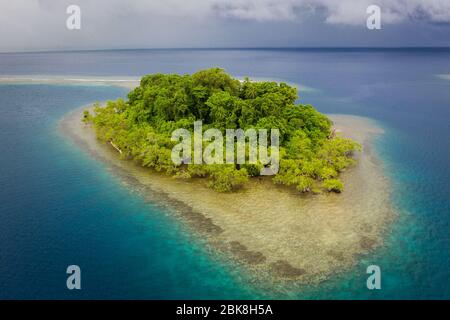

60,69,396,284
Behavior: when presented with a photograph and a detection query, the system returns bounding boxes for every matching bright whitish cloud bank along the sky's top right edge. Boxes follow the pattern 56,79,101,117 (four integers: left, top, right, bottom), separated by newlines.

213,0,450,25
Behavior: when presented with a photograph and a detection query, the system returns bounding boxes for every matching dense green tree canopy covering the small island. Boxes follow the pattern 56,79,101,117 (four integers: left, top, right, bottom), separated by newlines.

84,68,360,192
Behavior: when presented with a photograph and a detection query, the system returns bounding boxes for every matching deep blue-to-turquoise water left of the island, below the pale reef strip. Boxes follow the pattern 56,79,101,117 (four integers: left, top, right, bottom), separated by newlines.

0,85,264,299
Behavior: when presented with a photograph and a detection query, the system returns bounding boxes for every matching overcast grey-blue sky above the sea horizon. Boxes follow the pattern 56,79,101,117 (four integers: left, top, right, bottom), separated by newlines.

0,0,450,51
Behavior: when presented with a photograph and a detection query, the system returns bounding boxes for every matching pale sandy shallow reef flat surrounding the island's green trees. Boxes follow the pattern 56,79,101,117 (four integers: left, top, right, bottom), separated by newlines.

60,100,396,286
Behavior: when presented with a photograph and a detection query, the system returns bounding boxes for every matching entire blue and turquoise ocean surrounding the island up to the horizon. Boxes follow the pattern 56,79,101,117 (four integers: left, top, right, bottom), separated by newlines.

0,49,450,299
